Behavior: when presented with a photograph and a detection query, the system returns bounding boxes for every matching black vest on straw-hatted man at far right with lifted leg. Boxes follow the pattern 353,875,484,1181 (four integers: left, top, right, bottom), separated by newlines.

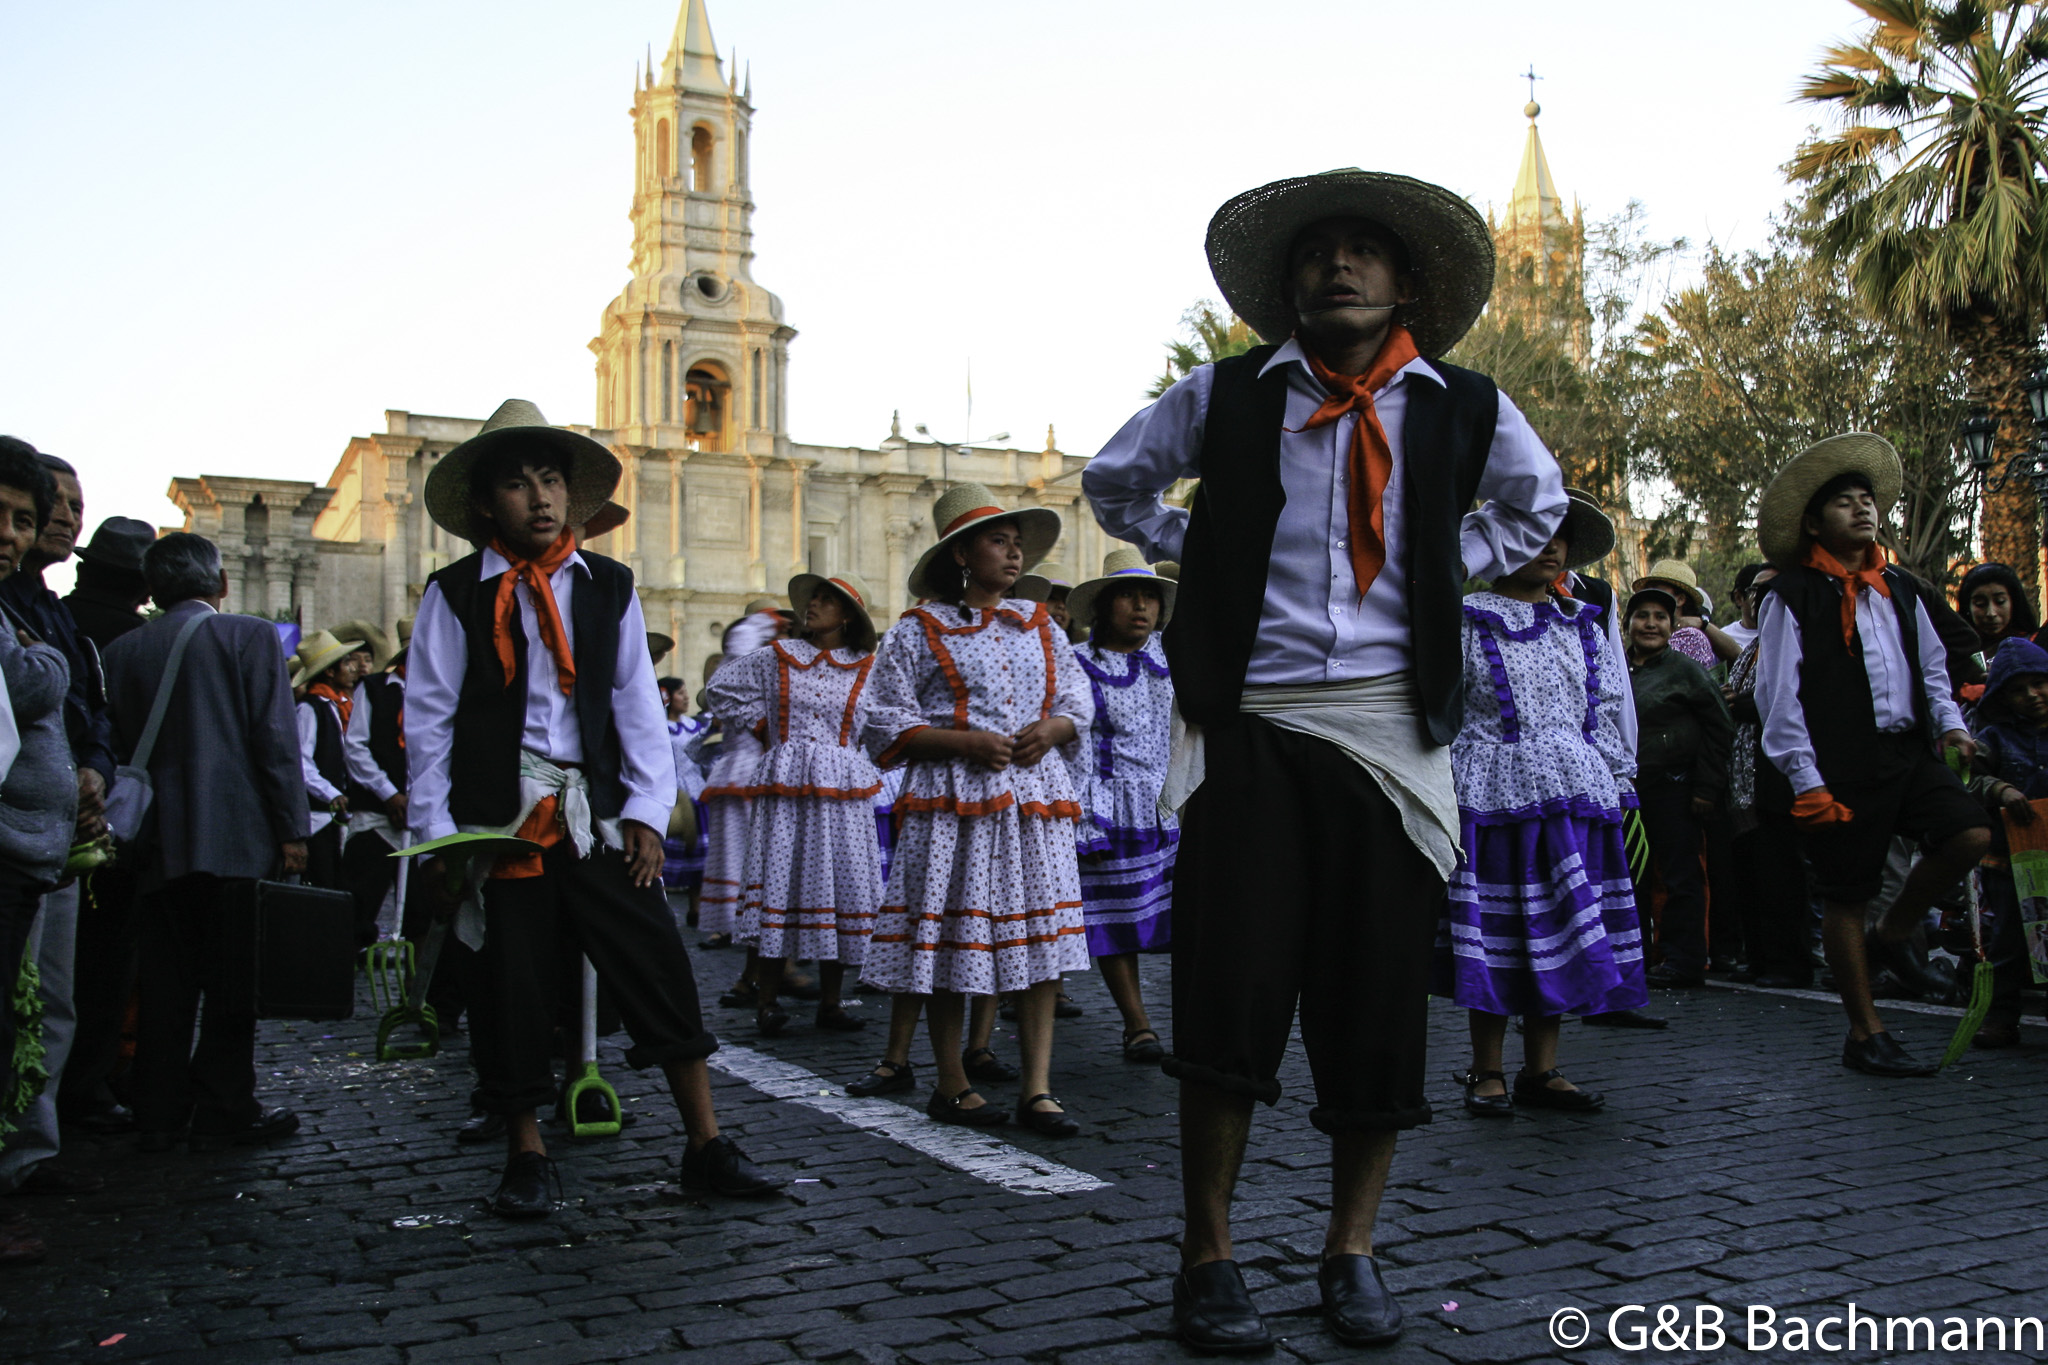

1765,565,1935,789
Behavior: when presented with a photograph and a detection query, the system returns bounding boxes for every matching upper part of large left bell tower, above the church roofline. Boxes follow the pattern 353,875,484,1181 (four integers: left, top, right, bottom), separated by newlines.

590,0,797,448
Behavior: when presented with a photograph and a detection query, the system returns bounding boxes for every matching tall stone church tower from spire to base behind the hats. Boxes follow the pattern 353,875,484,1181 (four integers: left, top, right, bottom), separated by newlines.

590,0,797,596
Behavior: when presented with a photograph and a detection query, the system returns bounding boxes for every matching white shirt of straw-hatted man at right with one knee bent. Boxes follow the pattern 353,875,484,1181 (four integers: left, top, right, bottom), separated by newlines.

1757,585,1964,796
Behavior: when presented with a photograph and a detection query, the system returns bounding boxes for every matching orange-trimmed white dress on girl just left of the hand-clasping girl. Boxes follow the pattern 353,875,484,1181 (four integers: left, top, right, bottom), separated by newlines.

711,641,883,966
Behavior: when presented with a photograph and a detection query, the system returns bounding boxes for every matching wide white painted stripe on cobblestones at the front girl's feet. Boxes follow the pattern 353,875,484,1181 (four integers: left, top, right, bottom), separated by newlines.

705,1044,1110,1195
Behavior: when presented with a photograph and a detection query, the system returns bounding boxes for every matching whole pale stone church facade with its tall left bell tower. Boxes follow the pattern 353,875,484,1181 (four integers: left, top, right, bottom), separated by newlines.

170,0,1108,671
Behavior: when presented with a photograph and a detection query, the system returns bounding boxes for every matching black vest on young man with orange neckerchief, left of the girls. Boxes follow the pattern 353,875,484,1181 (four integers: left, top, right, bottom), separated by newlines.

428,551,633,825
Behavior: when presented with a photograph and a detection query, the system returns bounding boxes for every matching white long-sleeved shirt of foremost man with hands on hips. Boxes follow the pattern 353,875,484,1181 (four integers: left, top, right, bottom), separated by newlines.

1081,340,1565,684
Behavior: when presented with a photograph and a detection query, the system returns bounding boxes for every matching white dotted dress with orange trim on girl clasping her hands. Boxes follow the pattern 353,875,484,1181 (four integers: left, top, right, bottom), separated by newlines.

862,602,1094,995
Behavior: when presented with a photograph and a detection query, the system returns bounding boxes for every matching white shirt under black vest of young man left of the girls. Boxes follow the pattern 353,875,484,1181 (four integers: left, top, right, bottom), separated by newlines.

406,548,676,843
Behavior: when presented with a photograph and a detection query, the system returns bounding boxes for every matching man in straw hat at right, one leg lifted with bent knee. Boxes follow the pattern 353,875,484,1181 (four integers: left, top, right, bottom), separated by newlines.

1757,432,1991,1076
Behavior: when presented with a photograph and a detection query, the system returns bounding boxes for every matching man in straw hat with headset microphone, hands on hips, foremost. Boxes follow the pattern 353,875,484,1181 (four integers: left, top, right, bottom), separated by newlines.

1081,170,1565,1349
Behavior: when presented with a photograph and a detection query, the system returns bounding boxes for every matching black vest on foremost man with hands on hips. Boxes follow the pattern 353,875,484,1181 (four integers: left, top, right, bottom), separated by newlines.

1165,346,1499,745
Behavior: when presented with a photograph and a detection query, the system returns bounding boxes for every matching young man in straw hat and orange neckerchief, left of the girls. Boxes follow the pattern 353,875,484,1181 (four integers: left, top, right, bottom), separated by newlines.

406,399,782,1218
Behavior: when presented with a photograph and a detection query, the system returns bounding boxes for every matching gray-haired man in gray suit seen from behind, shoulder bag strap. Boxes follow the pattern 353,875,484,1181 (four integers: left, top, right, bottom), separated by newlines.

106,532,309,1152
